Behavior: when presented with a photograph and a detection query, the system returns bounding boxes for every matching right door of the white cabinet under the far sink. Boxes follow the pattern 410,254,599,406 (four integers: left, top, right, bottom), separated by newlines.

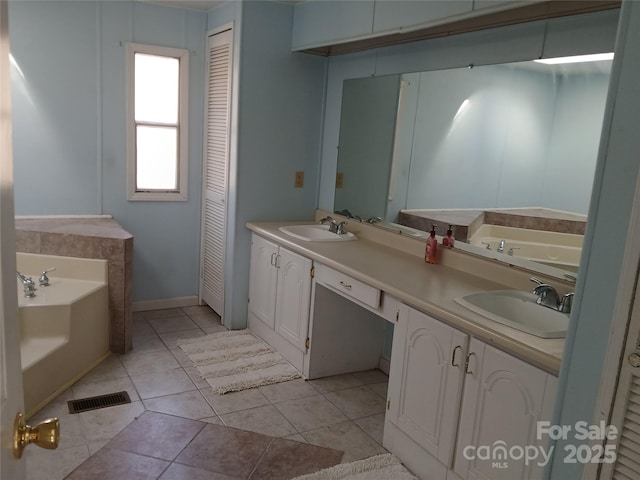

275,248,312,351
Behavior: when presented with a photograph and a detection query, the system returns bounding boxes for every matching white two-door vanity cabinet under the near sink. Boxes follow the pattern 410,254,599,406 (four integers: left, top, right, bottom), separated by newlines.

384,305,556,480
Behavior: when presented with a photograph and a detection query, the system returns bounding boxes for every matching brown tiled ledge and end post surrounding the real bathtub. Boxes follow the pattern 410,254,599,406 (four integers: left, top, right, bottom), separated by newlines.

16,217,133,353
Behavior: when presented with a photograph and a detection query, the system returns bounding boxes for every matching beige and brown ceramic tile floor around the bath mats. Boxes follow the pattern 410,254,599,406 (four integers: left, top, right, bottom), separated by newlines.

25,307,387,480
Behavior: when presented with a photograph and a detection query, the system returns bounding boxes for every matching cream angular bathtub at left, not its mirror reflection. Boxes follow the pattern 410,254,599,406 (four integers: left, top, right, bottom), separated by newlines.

17,253,109,418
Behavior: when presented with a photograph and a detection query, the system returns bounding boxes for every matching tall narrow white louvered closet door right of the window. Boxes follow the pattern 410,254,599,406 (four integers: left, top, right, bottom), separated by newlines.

200,30,233,315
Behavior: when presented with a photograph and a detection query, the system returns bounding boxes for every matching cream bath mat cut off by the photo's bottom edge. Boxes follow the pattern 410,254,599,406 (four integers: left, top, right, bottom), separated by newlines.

293,453,418,480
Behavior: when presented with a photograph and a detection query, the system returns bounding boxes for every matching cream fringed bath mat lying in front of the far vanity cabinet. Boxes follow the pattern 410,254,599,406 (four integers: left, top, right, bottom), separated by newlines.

178,330,302,395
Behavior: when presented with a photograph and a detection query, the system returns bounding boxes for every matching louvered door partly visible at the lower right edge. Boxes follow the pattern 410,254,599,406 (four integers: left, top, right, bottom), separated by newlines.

598,268,640,480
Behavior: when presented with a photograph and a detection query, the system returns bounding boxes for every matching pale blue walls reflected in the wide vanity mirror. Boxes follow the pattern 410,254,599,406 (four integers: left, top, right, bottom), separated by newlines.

335,61,611,221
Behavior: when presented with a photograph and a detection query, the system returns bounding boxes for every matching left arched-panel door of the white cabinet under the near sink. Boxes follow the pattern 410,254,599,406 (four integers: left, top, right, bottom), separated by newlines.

388,305,468,467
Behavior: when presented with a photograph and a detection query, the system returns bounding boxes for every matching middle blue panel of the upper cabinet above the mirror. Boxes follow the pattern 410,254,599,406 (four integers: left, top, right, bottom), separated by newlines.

373,0,473,33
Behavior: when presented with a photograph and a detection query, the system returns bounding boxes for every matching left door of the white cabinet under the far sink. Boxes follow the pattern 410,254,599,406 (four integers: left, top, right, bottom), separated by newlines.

249,235,278,328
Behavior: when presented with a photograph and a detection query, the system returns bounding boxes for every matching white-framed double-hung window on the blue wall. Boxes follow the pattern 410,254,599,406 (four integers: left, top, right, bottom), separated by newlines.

127,43,189,201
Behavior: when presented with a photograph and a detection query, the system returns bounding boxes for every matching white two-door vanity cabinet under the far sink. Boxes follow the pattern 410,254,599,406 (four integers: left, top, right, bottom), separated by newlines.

249,234,313,370
